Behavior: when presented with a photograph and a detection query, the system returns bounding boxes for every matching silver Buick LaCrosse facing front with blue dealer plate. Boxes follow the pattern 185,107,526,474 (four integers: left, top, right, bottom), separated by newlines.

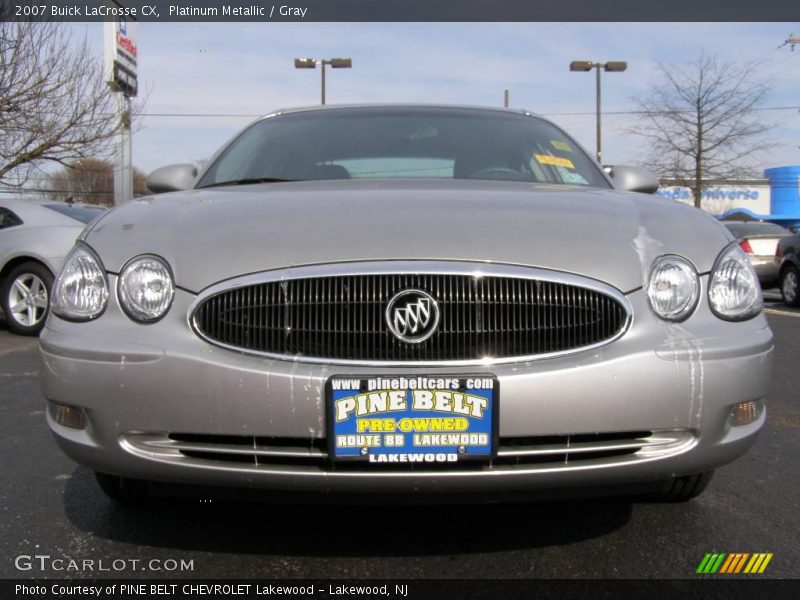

41,106,773,500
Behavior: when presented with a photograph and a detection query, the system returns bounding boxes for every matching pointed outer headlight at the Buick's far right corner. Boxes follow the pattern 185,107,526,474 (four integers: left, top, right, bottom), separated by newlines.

708,242,764,321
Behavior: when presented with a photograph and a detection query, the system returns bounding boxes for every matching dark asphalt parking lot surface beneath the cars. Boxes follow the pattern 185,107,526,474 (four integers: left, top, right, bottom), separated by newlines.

0,308,800,578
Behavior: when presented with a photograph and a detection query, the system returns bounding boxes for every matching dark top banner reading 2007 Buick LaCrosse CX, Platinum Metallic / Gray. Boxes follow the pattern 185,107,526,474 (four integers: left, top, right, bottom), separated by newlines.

6,0,800,23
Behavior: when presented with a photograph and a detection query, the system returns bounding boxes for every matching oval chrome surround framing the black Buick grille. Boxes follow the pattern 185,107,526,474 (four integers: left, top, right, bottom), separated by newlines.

186,260,633,367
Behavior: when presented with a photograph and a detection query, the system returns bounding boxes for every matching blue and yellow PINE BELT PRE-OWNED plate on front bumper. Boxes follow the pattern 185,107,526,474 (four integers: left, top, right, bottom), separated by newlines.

326,375,499,466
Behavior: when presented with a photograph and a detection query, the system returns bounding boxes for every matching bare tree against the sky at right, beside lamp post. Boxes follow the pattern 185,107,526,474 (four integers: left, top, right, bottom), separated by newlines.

631,55,771,208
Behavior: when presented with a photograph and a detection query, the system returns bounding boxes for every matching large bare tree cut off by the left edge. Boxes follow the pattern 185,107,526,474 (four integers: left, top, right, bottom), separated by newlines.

0,21,126,187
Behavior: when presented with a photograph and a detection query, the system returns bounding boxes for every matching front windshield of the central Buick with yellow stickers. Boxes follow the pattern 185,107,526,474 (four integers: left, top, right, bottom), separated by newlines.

198,107,610,188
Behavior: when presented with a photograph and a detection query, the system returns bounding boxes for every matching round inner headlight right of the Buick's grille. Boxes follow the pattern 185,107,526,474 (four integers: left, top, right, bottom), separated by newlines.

647,255,700,321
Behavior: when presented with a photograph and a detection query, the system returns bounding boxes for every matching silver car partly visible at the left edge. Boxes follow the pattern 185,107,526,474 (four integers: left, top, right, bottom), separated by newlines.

0,198,105,335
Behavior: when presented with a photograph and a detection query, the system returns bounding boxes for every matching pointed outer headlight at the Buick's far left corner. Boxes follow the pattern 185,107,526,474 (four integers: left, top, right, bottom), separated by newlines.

51,244,108,321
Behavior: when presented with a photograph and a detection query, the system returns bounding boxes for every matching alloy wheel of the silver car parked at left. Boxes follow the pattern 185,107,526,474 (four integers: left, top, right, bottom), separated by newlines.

0,262,53,335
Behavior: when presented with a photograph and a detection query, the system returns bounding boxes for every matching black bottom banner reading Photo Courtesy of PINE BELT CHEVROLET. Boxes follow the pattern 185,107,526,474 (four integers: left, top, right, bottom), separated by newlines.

0,576,800,600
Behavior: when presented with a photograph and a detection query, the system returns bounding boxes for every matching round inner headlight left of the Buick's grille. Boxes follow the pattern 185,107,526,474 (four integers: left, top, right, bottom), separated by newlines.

118,256,175,323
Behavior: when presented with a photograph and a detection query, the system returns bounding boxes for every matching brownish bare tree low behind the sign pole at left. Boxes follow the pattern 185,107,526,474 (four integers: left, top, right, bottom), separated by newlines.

42,158,148,206
